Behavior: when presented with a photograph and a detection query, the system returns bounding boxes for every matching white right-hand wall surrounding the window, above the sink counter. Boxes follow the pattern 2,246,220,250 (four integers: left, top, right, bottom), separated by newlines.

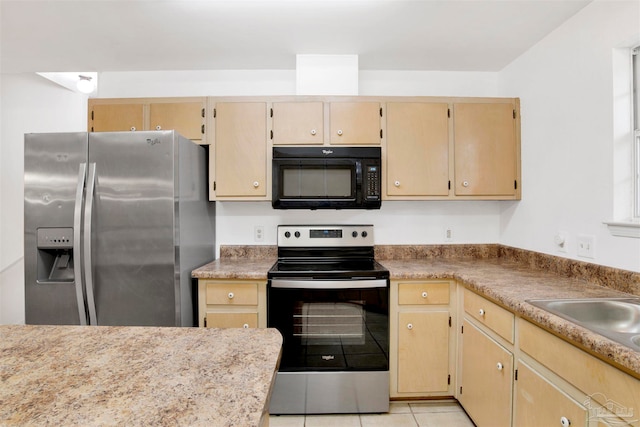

499,0,640,271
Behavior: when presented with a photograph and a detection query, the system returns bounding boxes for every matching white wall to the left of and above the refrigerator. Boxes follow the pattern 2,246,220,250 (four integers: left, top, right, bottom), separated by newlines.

0,74,87,324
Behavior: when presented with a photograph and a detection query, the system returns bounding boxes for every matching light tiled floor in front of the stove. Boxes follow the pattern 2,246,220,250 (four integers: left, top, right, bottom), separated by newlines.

269,400,474,427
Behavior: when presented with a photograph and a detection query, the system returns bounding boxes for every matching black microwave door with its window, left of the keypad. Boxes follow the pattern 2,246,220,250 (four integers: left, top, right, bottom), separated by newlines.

272,158,362,209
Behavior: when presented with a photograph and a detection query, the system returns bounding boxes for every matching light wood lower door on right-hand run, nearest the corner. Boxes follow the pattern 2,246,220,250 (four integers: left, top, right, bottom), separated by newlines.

460,320,513,427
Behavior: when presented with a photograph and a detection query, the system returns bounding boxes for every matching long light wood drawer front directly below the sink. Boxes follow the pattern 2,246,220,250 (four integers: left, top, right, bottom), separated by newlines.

518,319,640,420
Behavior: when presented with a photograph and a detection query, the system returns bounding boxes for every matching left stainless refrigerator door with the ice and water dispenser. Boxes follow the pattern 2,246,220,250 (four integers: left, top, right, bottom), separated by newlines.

24,133,87,325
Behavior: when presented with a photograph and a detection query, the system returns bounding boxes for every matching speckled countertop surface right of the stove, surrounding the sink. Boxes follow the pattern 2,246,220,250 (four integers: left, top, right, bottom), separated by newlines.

380,258,640,378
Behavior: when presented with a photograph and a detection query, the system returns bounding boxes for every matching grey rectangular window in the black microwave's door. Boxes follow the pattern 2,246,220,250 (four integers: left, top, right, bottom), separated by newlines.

282,167,352,198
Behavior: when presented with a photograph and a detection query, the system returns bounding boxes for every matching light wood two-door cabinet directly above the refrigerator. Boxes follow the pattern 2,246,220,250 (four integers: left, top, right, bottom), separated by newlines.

88,97,206,144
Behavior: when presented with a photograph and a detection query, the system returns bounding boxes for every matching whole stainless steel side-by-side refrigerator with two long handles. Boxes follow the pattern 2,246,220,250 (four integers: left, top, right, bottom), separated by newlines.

24,131,215,326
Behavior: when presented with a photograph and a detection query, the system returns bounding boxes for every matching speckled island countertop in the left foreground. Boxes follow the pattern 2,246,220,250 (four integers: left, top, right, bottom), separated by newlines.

0,325,282,426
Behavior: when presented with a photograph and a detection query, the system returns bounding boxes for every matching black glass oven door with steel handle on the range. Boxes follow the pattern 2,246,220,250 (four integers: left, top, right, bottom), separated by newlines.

267,279,389,372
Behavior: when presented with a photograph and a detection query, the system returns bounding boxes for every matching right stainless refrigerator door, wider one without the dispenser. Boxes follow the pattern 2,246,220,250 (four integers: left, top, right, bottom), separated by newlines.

85,131,179,326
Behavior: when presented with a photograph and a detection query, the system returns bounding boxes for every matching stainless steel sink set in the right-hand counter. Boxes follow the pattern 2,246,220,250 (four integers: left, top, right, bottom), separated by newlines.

527,298,640,351
